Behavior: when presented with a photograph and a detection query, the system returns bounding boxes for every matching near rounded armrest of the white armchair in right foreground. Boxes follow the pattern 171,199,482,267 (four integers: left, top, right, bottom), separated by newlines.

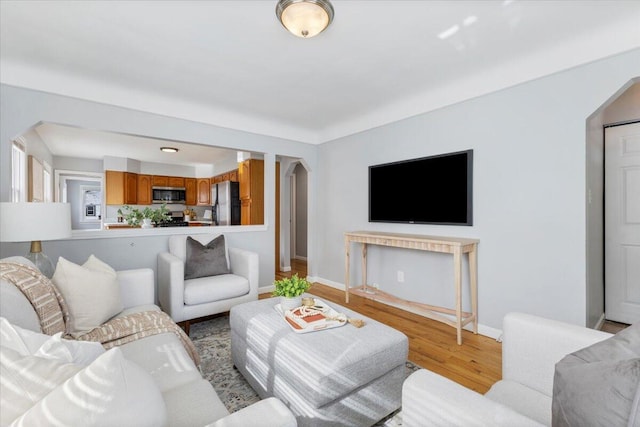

402,369,542,427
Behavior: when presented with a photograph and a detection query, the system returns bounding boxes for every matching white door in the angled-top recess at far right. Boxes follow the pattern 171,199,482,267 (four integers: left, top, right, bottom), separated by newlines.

604,123,640,324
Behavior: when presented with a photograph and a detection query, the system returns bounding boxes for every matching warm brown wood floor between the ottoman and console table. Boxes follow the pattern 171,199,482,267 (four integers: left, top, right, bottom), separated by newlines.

268,260,502,393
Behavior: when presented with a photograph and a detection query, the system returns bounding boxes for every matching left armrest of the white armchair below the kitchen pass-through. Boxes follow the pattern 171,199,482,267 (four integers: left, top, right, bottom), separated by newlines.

158,252,187,322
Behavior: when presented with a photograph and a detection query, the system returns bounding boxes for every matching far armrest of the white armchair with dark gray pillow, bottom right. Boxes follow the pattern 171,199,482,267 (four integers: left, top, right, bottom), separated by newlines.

502,313,611,396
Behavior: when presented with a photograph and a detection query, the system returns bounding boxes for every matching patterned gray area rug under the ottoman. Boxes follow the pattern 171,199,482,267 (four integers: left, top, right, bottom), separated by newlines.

189,315,420,427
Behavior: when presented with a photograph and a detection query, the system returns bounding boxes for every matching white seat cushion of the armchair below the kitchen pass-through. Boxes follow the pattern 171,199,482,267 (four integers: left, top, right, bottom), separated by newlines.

184,274,249,305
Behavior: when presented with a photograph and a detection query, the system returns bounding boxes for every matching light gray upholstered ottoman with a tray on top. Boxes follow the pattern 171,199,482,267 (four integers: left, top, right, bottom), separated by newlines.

230,298,408,426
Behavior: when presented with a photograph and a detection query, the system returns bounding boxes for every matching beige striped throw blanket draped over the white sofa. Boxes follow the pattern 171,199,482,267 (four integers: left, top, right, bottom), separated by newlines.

0,262,200,367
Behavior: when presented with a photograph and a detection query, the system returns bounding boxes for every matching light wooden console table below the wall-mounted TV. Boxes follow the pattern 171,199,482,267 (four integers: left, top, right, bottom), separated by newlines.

344,231,479,345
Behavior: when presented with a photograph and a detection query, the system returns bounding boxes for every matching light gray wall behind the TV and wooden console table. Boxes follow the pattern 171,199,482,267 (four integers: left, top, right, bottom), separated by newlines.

316,50,640,329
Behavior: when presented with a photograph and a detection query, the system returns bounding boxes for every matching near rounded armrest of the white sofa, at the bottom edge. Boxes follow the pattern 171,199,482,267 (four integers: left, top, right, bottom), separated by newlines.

206,397,298,427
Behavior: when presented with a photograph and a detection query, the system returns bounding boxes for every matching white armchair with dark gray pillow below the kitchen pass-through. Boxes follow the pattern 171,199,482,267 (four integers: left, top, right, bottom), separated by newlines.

158,234,259,334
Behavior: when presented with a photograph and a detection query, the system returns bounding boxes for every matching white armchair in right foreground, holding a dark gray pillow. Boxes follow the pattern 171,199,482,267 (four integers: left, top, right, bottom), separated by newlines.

402,313,611,427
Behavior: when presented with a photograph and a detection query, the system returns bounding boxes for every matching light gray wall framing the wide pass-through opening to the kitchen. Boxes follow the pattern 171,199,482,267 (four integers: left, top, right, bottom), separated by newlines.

0,85,317,287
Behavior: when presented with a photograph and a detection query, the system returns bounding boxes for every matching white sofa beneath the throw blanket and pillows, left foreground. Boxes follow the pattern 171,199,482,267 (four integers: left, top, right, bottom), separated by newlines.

0,257,296,427
